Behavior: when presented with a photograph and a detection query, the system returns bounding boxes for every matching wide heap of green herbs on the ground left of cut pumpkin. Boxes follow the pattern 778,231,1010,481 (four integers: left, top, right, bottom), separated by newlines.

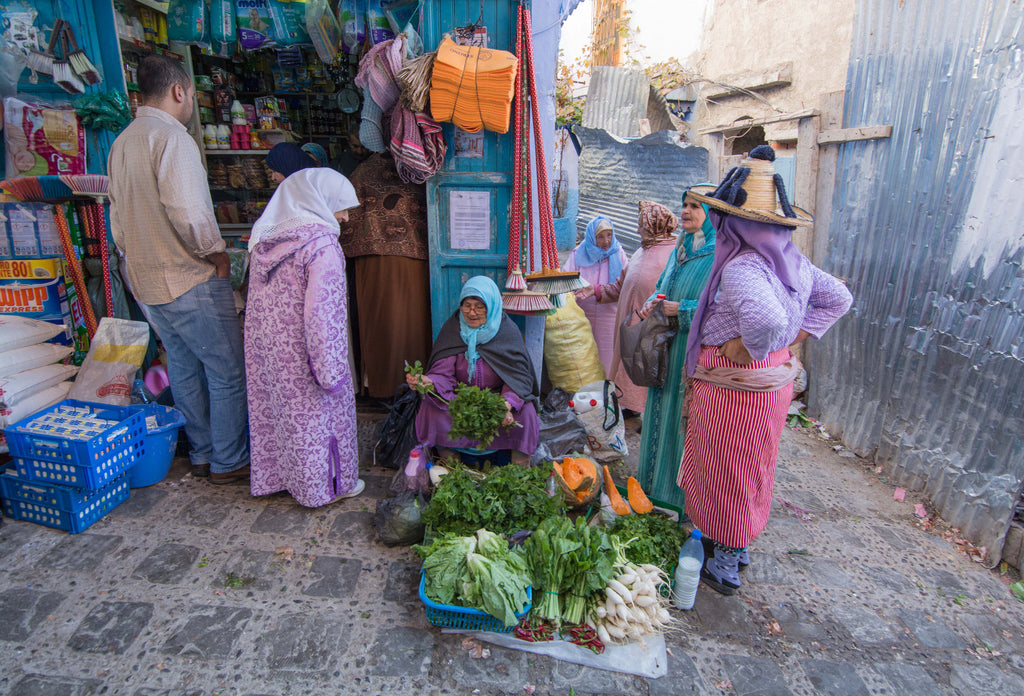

423,463,565,536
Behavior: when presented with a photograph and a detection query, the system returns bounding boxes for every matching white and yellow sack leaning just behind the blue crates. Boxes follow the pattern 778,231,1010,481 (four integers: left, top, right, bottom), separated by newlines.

70,317,150,406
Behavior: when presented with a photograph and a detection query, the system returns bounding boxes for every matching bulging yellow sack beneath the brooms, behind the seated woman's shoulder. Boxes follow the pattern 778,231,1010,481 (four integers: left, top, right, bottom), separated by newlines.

544,293,605,394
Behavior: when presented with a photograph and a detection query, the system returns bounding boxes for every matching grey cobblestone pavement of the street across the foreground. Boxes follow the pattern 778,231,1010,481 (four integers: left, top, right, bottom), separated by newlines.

0,413,1024,696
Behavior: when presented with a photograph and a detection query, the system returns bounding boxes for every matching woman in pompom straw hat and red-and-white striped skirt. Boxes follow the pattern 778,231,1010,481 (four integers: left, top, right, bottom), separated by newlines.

678,145,853,595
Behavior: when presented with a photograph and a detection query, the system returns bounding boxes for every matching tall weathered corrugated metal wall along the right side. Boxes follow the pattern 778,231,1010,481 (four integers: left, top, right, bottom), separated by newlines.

811,0,1024,564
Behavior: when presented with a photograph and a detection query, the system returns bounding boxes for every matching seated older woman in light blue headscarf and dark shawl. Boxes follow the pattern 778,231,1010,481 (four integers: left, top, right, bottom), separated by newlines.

406,275,541,465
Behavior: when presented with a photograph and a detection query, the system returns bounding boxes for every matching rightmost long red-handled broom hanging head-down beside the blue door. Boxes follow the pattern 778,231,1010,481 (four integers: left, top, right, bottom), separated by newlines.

516,4,587,295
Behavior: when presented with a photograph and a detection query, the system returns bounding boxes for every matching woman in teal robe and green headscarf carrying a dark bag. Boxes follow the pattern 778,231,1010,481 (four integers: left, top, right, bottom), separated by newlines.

630,184,715,507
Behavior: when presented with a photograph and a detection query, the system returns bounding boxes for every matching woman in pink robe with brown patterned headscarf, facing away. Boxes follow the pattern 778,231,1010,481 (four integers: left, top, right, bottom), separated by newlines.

600,201,679,414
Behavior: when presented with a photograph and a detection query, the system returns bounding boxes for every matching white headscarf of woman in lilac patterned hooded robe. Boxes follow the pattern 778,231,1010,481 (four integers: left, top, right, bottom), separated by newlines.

249,167,359,251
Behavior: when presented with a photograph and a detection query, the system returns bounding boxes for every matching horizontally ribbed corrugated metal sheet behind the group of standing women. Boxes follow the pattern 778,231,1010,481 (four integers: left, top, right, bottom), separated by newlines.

572,126,708,253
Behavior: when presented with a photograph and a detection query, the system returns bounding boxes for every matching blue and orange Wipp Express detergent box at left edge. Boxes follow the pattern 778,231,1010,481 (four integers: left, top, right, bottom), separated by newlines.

0,259,89,364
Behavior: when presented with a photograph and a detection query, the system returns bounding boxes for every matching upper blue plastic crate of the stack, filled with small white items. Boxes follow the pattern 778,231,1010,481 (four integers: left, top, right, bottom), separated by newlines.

4,399,145,490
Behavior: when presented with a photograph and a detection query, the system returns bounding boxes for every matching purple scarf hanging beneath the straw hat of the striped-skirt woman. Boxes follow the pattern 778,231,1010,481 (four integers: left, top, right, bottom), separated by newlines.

686,209,804,377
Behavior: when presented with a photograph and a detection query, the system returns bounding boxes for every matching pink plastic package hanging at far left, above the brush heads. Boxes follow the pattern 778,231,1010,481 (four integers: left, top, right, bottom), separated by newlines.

3,96,85,178
